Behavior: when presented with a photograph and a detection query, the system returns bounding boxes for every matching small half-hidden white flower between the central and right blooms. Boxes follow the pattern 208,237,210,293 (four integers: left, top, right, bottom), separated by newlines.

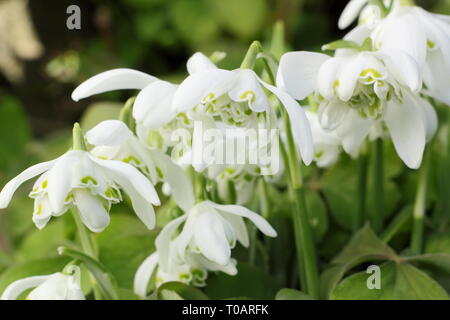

306,110,341,168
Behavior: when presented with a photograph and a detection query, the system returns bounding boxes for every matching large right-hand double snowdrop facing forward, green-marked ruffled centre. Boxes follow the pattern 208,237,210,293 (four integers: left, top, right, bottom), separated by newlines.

277,50,437,168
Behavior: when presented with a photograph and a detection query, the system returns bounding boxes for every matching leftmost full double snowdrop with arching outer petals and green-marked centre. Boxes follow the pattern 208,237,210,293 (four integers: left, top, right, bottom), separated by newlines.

0,125,160,232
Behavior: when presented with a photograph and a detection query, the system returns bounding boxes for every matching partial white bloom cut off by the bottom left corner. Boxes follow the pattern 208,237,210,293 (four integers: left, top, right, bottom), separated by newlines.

1,266,86,300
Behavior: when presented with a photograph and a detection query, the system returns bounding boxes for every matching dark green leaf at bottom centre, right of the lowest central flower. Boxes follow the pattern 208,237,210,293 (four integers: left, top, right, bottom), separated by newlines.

205,262,280,299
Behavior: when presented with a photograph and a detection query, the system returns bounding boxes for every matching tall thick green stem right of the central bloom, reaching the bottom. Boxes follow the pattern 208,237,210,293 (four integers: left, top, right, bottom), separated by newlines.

282,106,319,298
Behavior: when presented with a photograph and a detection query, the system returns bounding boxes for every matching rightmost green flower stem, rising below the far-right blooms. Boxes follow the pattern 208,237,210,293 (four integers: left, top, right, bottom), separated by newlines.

411,148,431,254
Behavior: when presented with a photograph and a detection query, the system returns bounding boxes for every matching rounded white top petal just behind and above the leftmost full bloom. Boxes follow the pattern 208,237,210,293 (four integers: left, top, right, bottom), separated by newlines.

86,120,133,147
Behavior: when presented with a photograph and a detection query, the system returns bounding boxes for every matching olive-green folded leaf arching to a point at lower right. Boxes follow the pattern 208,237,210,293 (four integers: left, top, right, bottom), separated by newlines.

320,225,397,298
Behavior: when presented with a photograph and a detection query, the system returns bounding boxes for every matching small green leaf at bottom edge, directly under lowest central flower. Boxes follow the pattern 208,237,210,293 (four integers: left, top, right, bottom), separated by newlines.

150,281,208,300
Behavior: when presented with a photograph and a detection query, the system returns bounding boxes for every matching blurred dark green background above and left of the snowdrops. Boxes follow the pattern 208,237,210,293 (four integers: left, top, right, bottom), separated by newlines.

0,0,450,271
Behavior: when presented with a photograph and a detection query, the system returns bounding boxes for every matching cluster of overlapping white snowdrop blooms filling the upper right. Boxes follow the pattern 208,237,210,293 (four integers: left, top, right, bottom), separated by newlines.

277,1,442,169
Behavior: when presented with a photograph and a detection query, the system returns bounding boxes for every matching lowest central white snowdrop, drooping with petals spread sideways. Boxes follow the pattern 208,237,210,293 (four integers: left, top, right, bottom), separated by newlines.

156,201,277,270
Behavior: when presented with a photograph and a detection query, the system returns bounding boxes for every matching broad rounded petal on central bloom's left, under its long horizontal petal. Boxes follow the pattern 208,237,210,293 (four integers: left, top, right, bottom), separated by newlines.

133,80,177,129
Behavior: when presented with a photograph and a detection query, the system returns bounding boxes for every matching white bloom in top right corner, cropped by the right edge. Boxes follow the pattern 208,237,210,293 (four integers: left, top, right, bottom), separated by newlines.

339,0,450,104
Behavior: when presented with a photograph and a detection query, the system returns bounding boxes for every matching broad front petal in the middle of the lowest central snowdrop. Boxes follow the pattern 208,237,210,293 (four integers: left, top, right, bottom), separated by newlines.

194,212,231,265
